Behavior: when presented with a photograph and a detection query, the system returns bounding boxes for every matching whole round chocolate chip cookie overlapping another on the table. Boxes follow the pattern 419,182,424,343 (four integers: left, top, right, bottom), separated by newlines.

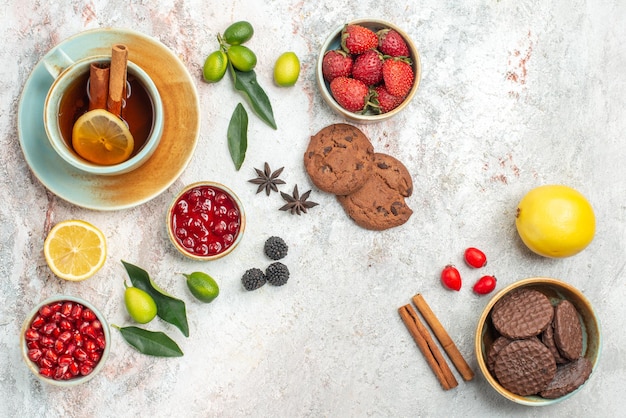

304,123,374,195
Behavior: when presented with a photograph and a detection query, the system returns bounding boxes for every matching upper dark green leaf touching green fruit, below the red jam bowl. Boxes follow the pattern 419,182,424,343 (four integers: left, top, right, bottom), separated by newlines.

122,260,189,337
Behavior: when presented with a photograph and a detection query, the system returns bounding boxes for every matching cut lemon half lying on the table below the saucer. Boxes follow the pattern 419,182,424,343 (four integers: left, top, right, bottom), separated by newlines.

43,220,107,281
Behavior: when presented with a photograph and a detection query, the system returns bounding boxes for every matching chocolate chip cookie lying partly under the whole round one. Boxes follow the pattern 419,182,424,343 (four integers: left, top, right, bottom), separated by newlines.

337,153,413,231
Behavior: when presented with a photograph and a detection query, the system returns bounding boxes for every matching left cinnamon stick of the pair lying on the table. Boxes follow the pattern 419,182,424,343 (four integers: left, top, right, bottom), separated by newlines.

398,305,458,390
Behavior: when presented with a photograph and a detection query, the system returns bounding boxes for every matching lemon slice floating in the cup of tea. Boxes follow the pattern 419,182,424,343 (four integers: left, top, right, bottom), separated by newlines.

72,109,135,165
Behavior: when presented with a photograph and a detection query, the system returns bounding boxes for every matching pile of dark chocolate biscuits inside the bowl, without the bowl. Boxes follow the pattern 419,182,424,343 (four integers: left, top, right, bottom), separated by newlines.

487,288,592,399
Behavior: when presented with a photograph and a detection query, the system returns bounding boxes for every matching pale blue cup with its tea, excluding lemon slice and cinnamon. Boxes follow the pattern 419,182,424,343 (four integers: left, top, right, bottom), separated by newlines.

43,49,164,175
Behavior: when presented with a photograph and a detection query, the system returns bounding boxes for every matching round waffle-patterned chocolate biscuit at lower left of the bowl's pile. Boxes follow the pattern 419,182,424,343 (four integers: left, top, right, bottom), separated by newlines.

493,337,556,396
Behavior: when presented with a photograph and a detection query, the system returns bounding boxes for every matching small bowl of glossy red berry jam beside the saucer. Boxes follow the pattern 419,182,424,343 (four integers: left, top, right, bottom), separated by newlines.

167,181,246,261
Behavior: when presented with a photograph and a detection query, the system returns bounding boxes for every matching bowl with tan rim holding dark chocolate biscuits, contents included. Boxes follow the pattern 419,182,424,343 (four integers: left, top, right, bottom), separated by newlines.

474,277,602,406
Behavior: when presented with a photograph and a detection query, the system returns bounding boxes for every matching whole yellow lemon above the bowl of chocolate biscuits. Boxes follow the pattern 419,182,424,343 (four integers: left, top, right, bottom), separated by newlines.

515,185,596,258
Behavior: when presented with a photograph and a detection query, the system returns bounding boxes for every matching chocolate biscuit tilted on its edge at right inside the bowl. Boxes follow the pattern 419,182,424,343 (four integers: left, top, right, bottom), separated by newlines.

554,300,583,360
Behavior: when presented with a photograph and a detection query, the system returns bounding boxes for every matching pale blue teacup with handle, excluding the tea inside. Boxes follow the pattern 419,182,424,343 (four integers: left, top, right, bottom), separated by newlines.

43,49,164,175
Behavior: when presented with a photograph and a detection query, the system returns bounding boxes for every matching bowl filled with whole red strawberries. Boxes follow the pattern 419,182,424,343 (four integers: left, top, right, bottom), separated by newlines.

316,19,421,123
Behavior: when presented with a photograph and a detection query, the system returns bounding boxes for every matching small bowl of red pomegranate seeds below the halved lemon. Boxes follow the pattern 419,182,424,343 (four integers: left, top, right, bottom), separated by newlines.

20,295,111,386
